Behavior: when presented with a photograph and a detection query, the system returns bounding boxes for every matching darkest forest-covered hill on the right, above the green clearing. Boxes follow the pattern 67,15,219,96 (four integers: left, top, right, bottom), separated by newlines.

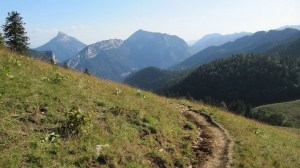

165,54,300,125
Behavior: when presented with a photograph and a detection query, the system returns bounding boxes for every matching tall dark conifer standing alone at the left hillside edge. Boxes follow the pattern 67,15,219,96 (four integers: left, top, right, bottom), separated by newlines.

2,11,29,53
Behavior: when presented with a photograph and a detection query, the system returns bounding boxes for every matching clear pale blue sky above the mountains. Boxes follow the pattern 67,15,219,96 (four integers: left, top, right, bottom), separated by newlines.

0,0,300,47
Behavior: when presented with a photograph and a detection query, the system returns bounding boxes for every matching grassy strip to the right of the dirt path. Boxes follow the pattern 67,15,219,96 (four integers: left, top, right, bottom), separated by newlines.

181,100,300,168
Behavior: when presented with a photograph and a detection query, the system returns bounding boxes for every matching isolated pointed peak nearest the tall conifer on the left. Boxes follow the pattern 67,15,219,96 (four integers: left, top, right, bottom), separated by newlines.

35,32,86,63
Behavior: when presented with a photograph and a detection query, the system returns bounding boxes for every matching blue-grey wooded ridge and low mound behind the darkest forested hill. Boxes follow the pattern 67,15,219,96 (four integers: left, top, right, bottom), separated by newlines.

125,29,300,91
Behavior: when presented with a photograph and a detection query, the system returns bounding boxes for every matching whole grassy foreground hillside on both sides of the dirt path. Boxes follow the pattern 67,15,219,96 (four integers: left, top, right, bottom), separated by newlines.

0,50,300,167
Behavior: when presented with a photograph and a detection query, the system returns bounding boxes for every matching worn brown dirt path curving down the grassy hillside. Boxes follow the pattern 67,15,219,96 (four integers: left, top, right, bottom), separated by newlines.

180,105,233,168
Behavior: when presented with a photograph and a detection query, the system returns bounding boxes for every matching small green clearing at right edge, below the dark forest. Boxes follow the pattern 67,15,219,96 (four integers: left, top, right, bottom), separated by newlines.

253,100,300,128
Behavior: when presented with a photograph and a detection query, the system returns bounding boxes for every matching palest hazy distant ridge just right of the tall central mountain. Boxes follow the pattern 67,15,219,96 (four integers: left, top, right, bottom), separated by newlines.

191,32,251,54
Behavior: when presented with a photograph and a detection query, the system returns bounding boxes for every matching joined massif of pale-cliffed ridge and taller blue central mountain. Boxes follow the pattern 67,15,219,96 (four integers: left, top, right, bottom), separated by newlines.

67,30,190,81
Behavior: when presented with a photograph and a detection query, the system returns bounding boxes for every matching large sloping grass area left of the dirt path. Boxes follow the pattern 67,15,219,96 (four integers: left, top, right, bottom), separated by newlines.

0,49,196,167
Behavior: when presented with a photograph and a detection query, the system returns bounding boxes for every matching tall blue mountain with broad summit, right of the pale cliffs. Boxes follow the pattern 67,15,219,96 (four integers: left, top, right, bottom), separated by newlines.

122,30,191,69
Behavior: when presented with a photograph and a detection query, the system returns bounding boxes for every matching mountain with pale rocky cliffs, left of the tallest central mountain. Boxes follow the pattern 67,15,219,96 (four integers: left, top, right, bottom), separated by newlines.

67,39,130,81
